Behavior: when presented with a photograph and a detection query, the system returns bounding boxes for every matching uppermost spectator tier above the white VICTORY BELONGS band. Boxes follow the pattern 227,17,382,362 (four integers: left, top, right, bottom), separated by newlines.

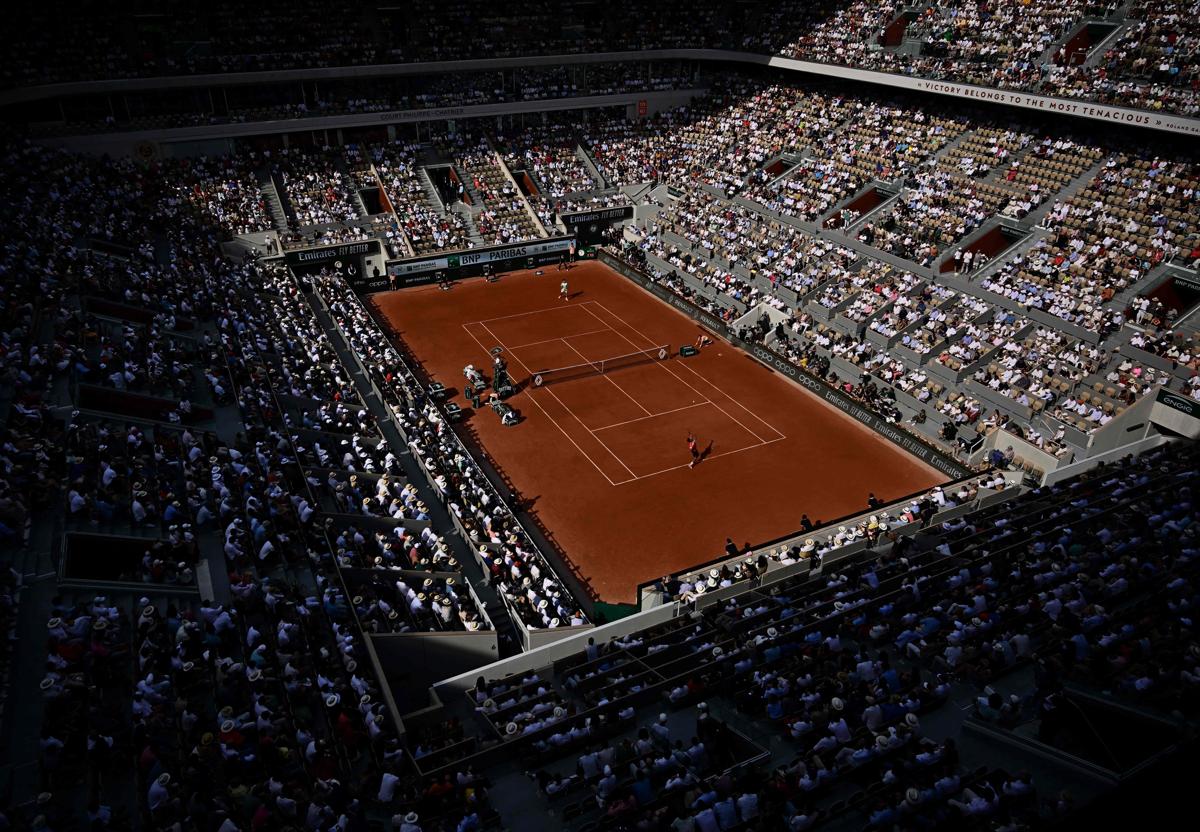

4,0,1200,117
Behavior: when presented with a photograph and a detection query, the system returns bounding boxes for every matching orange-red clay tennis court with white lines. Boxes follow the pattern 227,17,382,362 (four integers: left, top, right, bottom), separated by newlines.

371,262,946,603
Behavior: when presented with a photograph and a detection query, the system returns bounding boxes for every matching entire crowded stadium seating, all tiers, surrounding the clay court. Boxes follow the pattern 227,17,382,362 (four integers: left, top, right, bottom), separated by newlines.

0,0,1200,832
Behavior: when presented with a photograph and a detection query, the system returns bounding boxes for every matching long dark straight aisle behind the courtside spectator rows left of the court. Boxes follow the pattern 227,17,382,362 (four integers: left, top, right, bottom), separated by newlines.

305,285,521,658
